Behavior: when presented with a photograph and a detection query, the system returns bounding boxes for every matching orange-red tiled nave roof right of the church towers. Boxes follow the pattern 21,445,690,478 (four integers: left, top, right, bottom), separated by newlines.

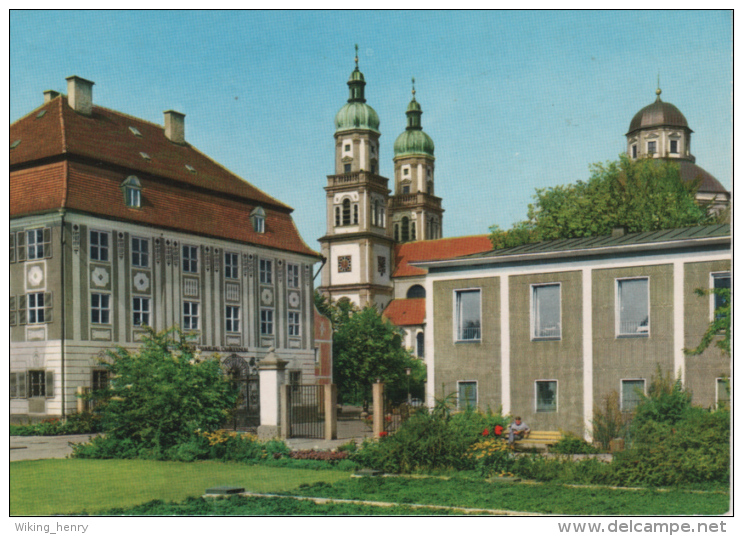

392,235,493,276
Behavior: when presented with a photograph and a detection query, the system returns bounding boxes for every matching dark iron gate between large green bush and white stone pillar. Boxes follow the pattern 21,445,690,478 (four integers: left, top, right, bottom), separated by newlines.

222,354,261,433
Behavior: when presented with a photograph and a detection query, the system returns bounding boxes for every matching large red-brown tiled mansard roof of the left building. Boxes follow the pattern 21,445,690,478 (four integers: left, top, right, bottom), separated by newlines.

10,96,317,256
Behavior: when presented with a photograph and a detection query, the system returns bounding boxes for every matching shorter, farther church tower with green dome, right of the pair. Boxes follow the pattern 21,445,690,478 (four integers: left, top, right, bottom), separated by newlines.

390,78,444,243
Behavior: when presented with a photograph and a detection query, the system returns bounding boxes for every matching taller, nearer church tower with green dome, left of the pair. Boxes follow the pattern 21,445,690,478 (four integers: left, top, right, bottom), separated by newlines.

318,46,394,311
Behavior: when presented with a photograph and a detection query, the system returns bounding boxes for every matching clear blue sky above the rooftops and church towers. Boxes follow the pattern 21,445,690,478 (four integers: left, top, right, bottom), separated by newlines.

10,11,733,249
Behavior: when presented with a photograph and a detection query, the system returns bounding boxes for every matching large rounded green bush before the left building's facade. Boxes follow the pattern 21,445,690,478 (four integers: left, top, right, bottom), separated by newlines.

94,328,237,453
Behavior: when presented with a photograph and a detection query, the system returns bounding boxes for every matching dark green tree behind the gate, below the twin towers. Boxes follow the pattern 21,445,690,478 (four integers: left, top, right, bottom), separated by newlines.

315,293,425,404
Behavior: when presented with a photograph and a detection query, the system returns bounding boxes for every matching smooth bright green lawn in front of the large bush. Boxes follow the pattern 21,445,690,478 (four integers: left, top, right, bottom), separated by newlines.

10,459,350,515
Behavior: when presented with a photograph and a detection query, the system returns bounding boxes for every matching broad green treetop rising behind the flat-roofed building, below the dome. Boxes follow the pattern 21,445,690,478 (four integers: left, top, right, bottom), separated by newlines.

490,155,713,249
